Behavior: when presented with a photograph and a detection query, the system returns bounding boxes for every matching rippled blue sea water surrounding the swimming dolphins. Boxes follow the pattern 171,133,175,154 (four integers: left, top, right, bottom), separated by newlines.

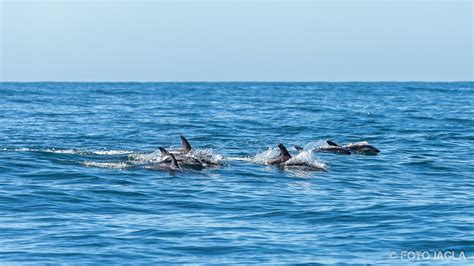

0,82,474,264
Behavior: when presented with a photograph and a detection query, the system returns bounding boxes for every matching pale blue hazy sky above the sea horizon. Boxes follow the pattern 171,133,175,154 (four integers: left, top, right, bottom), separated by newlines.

0,0,473,81
